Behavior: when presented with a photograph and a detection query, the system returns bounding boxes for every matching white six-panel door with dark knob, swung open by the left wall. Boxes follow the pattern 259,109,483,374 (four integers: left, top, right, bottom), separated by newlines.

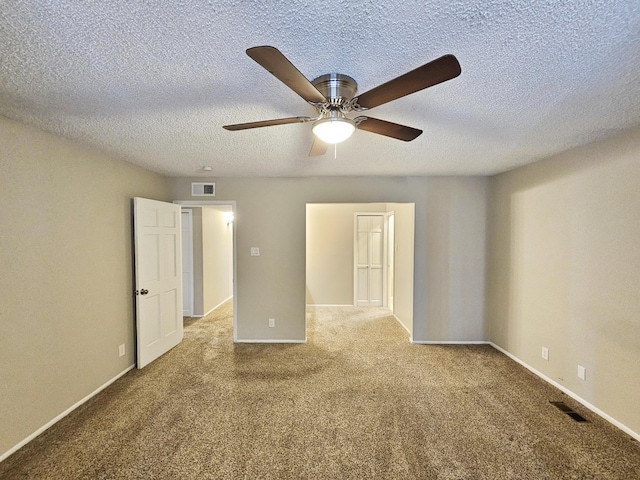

133,197,183,368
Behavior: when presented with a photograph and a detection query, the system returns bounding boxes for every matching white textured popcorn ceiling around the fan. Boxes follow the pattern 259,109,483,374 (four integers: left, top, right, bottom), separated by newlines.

0,0,640,176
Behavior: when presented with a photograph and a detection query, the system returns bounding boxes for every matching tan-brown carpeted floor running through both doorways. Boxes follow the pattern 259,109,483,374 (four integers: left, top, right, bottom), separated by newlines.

0,302,640,480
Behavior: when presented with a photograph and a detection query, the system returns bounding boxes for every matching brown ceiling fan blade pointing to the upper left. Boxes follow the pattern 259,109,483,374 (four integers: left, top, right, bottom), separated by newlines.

247,46,327,103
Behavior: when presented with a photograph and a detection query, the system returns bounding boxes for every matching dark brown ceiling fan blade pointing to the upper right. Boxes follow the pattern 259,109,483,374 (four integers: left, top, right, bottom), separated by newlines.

358,55,462,108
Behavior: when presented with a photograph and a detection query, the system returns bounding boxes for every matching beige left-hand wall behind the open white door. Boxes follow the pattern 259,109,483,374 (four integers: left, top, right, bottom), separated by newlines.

0,117,170,455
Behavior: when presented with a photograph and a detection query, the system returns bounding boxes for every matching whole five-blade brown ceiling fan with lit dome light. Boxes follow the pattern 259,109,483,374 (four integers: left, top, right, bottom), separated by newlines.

223,46,461,157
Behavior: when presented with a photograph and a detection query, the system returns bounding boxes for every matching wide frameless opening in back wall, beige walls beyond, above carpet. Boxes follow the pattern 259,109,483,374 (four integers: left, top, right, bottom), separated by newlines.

306,203,415,334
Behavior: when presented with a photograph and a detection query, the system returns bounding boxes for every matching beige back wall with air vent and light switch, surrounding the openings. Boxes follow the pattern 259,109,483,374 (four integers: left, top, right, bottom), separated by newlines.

172,177,488,341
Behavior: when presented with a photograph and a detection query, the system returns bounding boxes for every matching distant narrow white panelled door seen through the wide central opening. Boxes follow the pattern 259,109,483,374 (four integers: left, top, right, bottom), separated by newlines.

354,214,384,306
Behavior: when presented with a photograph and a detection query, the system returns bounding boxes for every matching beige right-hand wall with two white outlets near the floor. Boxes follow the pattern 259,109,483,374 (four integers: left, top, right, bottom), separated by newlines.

488,126,640,432
